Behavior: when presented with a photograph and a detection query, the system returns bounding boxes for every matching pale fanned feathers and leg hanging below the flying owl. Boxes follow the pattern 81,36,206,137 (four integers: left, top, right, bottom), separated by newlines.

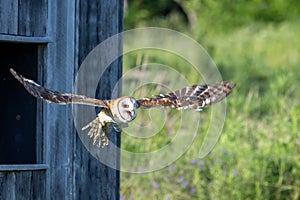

82,109,116,148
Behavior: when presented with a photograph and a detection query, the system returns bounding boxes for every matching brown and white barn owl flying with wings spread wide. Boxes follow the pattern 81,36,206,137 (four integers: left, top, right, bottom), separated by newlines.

10,69,235,147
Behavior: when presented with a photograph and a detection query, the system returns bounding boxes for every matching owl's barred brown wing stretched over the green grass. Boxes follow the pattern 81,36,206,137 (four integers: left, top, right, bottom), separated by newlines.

137,81,235,110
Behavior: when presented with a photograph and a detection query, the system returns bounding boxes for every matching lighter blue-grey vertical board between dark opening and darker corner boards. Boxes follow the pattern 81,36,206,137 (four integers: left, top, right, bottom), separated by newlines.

43,0,76,199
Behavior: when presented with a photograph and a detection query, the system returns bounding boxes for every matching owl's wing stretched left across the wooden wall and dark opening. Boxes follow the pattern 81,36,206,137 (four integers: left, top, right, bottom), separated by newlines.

10,68,109,108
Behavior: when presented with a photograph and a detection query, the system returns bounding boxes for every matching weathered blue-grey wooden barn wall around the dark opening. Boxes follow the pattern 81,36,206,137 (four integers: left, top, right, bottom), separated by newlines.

0,0,123,200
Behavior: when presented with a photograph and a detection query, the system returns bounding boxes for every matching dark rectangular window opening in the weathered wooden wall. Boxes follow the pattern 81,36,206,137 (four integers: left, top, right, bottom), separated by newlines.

0,42,38,164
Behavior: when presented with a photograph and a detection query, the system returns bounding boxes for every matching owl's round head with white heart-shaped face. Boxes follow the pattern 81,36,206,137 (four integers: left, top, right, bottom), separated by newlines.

112,96,137,123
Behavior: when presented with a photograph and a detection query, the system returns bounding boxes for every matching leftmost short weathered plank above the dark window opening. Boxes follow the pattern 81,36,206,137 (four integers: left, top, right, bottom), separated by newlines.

0,0,18,35
